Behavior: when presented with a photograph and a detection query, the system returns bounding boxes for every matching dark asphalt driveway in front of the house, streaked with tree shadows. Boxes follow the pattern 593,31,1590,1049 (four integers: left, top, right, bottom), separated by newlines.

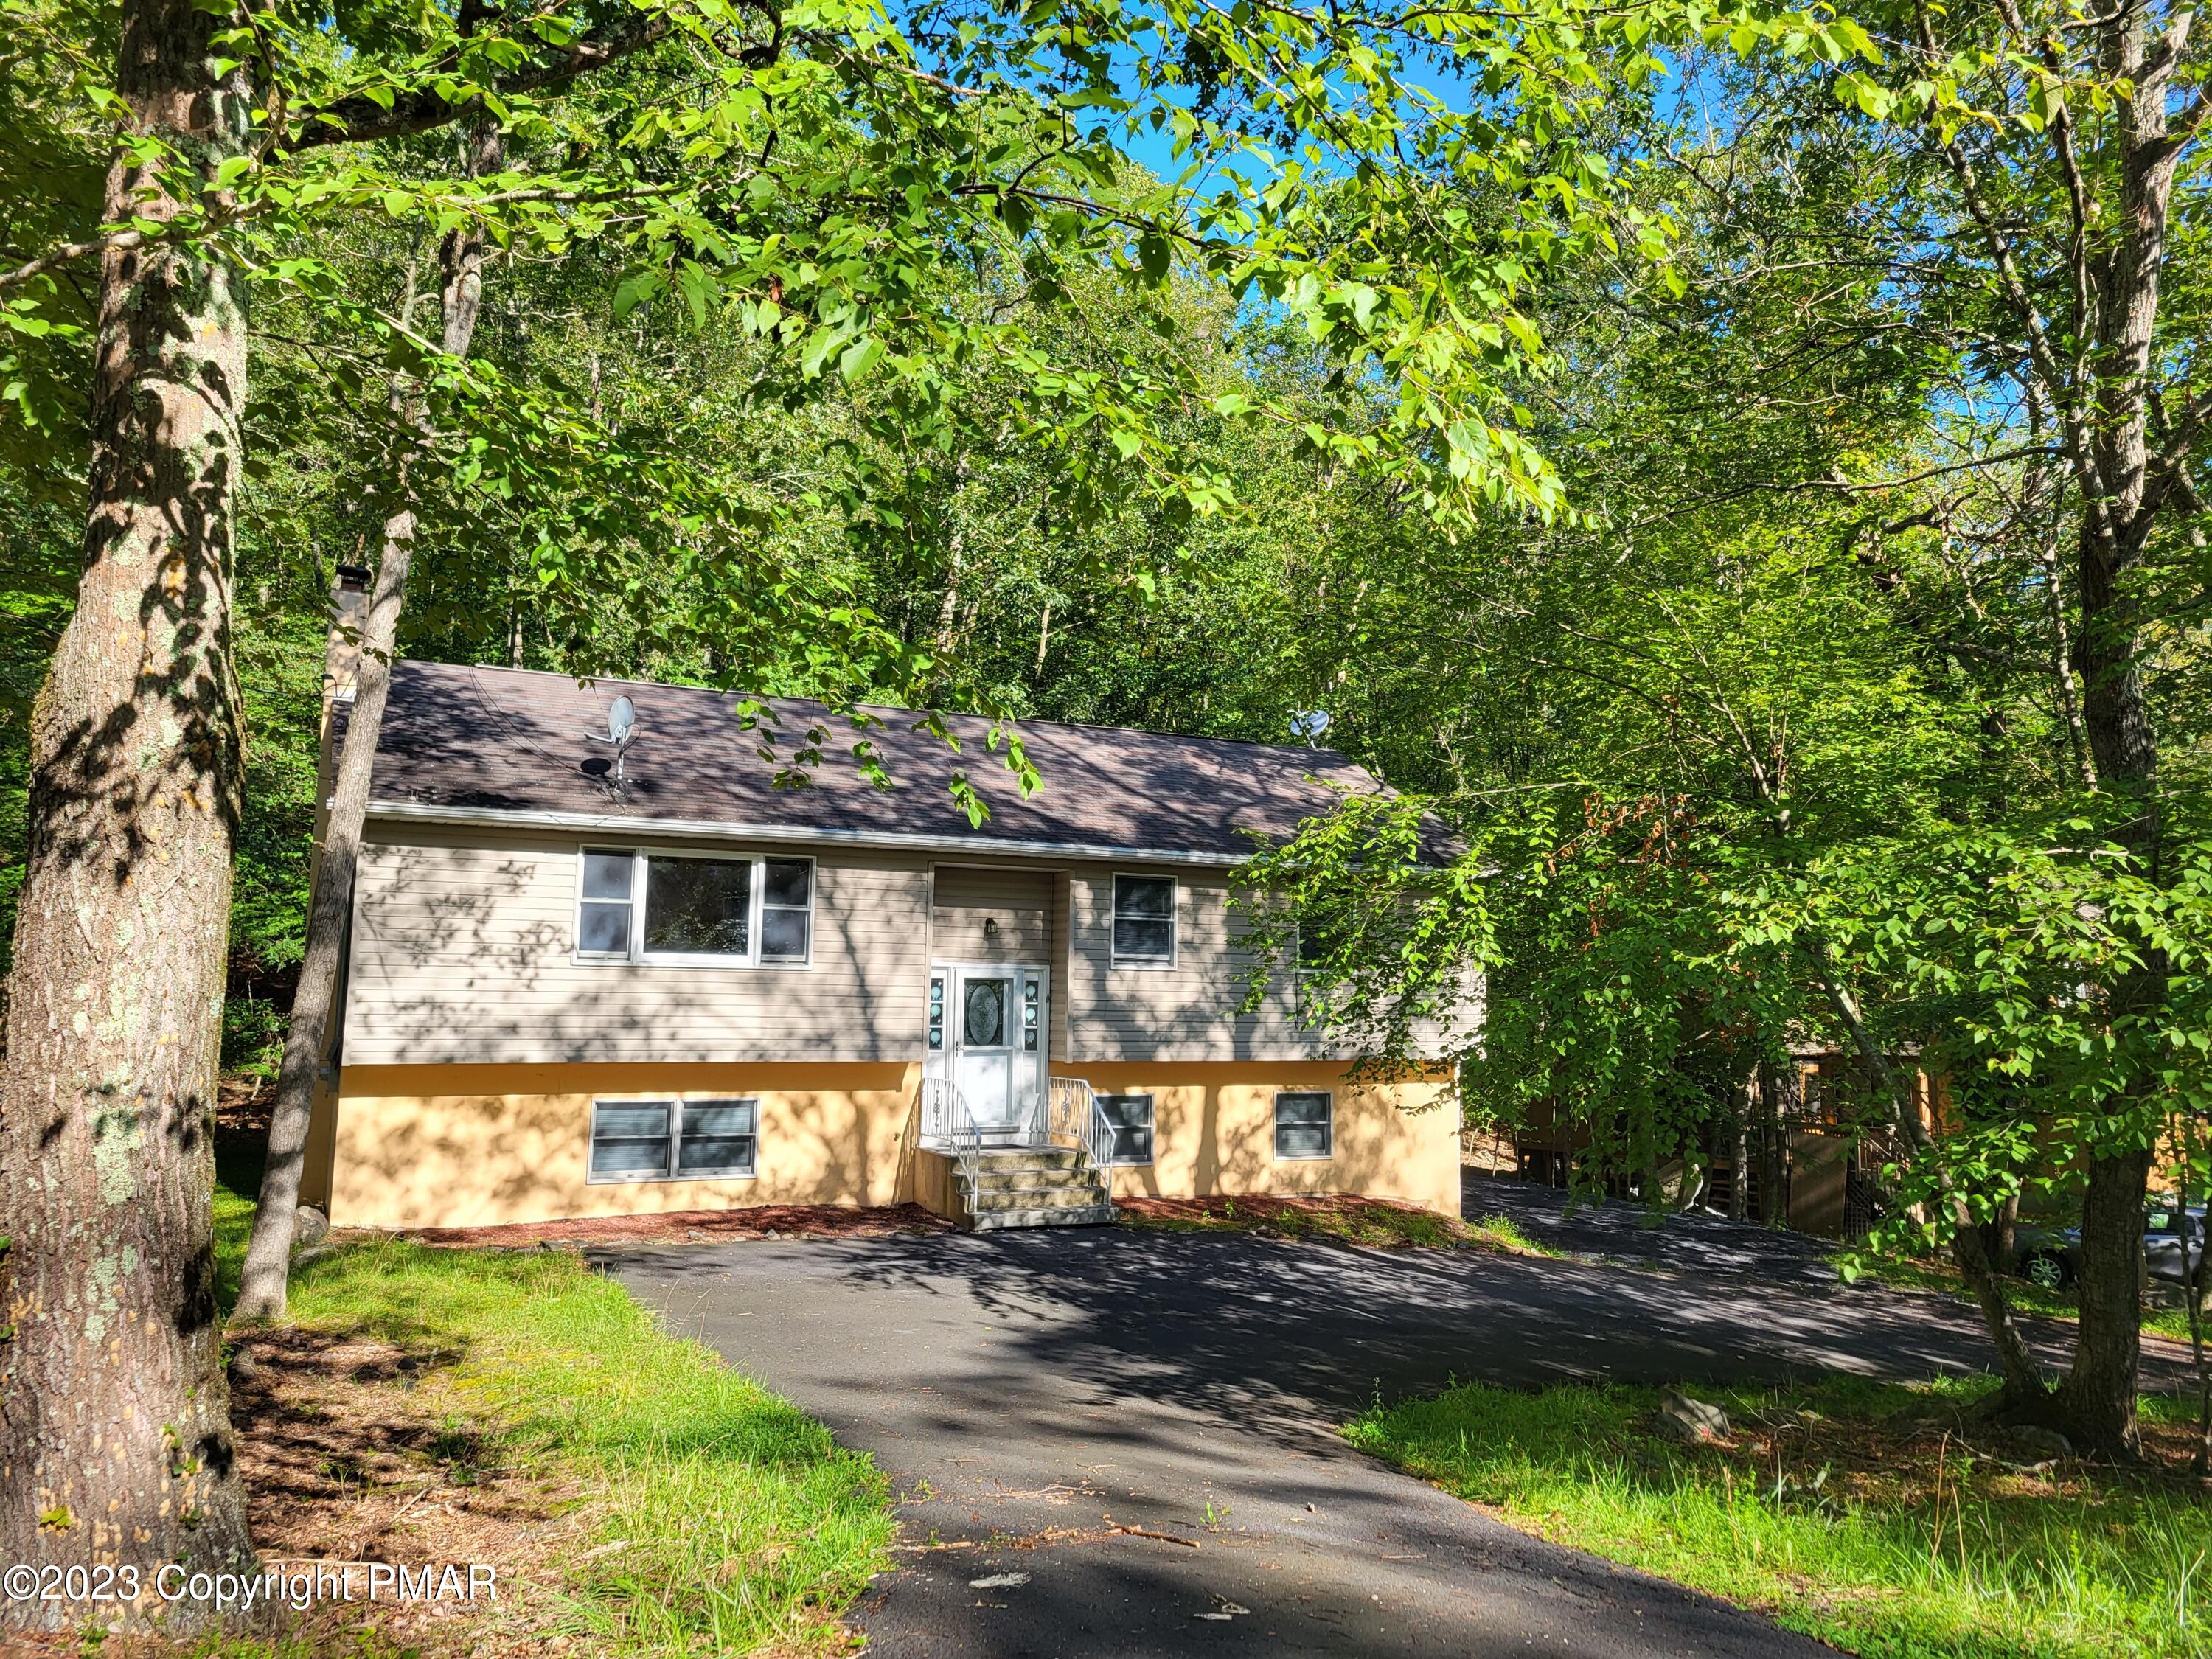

611,1228,2106,1659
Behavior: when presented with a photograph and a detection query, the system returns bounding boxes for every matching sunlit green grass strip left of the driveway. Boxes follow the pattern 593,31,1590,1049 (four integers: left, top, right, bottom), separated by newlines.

204,1159,894,1657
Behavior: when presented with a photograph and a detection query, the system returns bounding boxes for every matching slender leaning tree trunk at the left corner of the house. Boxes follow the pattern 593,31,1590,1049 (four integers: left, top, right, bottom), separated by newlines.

234,124,500,1323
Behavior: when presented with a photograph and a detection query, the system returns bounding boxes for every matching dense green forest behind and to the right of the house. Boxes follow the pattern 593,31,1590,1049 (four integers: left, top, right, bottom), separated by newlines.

0,7,2212,1478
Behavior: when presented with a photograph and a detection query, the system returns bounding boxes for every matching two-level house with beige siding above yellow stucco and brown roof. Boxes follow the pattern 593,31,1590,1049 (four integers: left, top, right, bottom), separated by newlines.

303,653,1460,1228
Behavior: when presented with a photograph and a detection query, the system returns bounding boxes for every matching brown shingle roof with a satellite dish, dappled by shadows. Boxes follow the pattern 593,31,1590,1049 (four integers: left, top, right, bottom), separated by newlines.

372,661,1380,858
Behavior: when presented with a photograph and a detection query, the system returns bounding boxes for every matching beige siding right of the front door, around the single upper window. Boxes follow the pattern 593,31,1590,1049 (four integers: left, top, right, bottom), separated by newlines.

1066,865,1332,1066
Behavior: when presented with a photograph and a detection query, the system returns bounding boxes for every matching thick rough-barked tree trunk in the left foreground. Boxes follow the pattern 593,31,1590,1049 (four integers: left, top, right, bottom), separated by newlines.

0,0,254,1630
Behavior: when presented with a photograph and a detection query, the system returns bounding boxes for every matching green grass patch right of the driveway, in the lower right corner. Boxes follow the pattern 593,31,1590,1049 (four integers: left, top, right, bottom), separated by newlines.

1347,1378,2212,1659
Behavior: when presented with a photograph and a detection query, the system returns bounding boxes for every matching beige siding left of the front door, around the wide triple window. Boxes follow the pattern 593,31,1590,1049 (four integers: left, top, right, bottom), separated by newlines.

343,823,929,1066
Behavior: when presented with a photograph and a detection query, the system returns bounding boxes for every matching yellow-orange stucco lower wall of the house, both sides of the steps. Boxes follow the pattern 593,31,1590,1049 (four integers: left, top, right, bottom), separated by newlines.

323,1062,1460,1228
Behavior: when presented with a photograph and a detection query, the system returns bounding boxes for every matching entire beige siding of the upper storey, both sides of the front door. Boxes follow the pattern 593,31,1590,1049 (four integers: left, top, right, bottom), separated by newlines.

343,823,1482,1066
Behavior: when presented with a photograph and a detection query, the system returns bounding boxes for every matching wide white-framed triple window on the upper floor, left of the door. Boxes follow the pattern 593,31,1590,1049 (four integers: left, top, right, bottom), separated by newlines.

575,847,814,967
